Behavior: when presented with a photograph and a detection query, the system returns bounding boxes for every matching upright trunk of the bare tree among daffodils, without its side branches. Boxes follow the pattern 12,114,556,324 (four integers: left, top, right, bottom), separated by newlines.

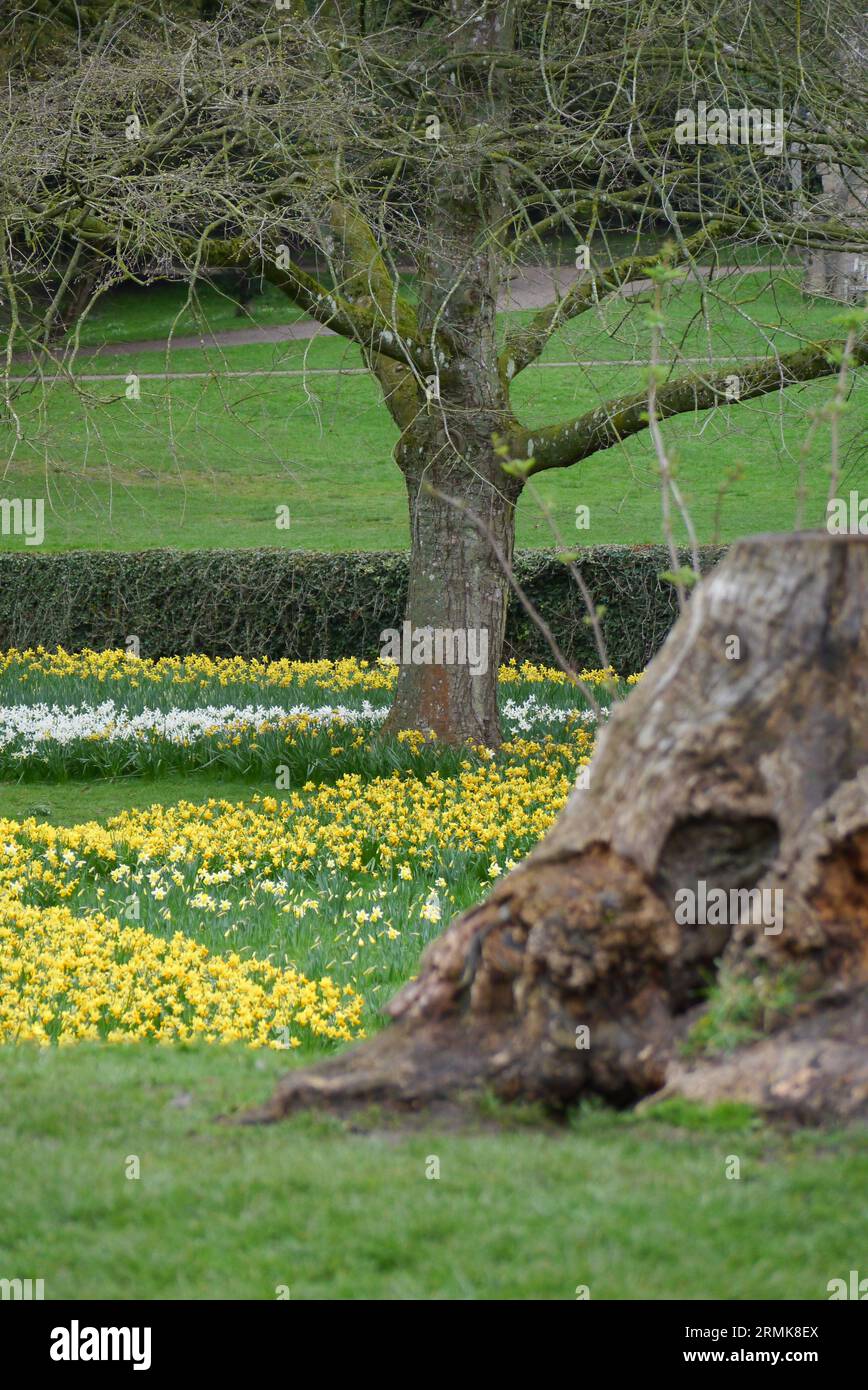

385,0,520,748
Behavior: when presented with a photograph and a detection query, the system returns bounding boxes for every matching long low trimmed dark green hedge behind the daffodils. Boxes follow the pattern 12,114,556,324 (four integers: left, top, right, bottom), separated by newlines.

0,545,723,673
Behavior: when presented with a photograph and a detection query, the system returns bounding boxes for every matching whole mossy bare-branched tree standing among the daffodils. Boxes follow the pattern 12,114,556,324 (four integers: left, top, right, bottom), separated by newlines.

0,0,868,745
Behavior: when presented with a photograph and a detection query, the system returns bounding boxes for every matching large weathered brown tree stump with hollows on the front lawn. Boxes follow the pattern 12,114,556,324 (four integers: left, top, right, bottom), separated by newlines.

250,534,868,1119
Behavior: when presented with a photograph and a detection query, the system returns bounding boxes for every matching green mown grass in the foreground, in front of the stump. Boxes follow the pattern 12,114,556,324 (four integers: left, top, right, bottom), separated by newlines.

0,1045,868,1300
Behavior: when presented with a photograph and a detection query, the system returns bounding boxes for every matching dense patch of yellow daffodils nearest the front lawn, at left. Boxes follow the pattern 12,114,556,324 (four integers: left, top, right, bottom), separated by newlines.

0,902,363,1048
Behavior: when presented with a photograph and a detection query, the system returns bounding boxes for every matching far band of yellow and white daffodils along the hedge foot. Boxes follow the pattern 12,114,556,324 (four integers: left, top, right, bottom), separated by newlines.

0,648,636,785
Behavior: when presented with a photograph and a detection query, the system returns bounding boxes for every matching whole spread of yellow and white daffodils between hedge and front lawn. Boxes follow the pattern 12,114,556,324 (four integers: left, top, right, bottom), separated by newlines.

0,652,637,1048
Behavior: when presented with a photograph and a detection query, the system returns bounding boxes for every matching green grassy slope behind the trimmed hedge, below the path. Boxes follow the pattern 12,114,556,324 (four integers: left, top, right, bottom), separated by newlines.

0,277,868,549
